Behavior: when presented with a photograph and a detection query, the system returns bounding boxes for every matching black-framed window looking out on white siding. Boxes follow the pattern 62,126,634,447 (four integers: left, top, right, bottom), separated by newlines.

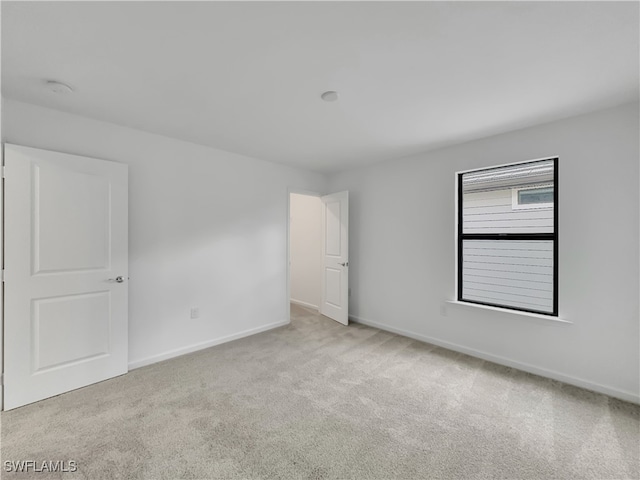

457,158,558,316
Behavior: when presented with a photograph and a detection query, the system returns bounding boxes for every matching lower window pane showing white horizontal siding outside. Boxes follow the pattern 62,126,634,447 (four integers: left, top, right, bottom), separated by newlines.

462,240,553,312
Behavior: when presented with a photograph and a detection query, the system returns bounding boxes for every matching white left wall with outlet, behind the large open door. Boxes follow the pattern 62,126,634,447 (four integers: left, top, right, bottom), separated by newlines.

2,99,325,367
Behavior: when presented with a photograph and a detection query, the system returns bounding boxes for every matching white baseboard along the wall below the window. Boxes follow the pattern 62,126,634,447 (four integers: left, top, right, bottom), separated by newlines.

349,315,640,404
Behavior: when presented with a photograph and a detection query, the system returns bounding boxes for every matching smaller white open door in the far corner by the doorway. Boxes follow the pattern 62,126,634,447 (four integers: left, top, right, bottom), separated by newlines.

320,192,349,325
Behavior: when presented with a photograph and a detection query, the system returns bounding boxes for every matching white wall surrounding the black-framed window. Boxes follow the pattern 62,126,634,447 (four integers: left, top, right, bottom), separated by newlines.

329,103,640,402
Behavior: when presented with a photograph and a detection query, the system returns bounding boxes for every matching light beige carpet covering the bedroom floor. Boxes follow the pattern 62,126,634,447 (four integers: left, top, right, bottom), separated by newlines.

1,307,640,480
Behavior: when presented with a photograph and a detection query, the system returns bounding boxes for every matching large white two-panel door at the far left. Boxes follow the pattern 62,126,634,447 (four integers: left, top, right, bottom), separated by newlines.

4,144,128,410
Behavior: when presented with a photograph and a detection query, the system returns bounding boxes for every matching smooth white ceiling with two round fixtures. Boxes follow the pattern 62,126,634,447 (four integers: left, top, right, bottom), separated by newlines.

2,2,640,173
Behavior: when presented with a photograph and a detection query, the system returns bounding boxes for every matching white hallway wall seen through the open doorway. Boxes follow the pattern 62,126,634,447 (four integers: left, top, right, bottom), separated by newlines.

290,193,322,309
